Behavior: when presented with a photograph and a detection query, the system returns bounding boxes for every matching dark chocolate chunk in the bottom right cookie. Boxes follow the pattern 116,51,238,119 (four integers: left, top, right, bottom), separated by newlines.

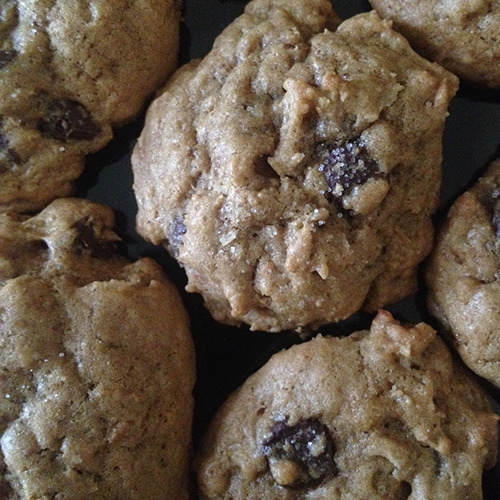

262,418,336,488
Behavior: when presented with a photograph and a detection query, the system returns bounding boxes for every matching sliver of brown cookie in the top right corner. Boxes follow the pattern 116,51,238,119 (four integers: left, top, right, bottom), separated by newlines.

370,0,500,89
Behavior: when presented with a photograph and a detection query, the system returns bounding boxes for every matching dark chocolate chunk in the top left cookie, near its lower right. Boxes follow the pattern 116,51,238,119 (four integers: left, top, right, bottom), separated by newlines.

38,99,100,142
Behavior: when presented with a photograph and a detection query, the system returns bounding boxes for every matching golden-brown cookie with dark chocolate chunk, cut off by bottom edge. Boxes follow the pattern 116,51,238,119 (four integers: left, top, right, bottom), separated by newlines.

195,311,498,500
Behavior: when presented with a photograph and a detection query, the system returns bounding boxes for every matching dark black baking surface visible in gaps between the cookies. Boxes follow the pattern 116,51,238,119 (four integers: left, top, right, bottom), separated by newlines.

77,0,500,500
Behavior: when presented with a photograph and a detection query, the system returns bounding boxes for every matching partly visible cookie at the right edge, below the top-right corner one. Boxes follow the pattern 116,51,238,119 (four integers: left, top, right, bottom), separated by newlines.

426,160,500,387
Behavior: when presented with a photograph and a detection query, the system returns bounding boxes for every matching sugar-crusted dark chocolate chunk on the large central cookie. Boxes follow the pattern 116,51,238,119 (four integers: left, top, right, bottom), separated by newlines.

318,138,383,198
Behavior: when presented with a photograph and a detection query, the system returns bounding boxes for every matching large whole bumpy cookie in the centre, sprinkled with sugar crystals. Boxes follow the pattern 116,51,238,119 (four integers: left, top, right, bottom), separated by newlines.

132,0,457,331
